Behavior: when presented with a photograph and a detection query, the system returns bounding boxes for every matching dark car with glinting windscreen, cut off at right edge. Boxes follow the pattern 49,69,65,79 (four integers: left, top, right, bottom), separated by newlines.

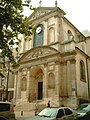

76,103,90,119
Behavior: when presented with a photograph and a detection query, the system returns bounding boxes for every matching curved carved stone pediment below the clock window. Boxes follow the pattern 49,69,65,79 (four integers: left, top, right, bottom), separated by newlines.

19,46,59,62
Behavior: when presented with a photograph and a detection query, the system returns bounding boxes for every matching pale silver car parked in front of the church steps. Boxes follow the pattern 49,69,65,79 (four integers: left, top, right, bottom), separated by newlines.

26,107,77,120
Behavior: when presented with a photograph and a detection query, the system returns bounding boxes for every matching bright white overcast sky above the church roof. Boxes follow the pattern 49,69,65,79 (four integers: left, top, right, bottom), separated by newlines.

24,0,90,32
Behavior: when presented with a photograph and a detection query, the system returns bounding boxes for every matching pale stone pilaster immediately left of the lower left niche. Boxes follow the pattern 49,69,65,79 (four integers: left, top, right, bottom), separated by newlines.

17,70,22,99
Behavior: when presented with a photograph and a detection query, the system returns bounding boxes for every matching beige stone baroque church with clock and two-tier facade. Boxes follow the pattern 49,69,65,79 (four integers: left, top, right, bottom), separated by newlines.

1,1,90,110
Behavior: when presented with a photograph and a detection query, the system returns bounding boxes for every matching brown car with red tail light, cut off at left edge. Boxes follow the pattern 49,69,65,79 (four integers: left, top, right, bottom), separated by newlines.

0,101,15,120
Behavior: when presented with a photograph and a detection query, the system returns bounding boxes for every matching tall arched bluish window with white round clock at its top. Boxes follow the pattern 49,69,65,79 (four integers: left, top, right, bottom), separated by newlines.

33,25,44,47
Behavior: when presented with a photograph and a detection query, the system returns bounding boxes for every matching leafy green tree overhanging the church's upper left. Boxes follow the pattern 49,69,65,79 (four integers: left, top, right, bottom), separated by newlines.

0,0,33,62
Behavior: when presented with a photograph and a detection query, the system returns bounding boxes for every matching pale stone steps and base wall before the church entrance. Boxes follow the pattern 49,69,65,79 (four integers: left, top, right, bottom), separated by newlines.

15,100,58,113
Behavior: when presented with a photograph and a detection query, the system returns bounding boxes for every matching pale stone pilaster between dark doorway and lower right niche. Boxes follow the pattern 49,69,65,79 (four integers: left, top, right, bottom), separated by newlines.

43,65,48,98
